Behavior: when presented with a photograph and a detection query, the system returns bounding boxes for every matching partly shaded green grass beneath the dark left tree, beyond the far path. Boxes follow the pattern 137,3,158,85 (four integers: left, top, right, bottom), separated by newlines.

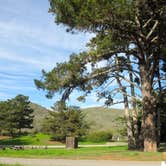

0,133,60,145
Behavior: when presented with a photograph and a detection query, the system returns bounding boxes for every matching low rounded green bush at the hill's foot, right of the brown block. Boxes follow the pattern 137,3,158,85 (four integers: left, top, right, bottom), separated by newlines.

86,131,112,142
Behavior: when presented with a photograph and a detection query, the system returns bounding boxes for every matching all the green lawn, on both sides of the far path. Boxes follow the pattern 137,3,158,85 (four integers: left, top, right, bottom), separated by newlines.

0,133,166,161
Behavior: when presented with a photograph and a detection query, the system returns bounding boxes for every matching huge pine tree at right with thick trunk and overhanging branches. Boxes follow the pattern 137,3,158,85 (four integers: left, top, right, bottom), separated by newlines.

36,0,166,151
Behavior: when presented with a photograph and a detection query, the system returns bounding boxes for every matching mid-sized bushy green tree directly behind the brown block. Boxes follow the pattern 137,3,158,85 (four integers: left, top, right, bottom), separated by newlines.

43,105,89,142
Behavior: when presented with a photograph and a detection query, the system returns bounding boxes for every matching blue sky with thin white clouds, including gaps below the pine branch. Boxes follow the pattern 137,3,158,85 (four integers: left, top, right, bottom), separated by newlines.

0,0,124,108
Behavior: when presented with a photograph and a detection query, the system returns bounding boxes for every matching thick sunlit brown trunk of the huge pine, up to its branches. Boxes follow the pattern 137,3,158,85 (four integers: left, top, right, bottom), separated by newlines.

139,54,157,152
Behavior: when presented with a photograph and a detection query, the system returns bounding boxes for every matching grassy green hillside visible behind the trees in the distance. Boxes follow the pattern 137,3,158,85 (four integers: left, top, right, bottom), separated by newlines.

31,103,124,133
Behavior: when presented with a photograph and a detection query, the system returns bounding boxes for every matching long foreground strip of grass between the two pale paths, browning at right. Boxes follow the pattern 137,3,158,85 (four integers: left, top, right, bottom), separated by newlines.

0,146,166,161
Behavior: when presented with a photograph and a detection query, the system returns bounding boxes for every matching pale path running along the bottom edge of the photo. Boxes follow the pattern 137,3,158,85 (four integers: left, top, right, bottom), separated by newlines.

0,157,161,166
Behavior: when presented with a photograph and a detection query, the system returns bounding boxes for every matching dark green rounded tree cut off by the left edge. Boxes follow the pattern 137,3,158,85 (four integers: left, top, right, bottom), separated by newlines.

0,95,33,136
